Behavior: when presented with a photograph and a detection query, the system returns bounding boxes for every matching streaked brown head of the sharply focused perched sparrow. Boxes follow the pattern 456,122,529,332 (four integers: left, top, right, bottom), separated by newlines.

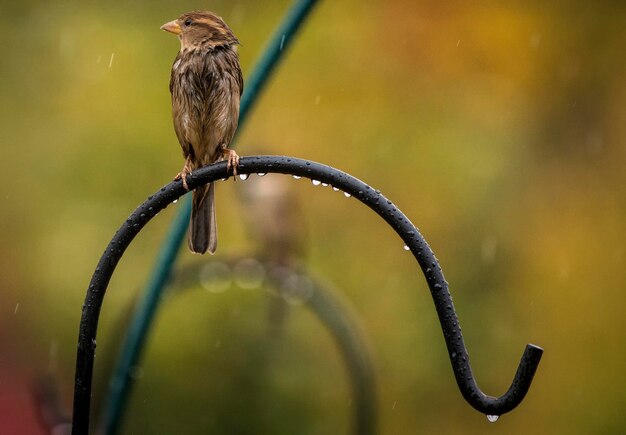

161,11,239,51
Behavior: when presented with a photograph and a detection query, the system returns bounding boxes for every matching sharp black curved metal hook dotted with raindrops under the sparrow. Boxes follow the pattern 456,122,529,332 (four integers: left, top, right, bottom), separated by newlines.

72,156,543,435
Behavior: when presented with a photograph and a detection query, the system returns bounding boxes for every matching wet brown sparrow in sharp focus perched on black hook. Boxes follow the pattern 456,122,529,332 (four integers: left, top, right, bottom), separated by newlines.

161,11,243,254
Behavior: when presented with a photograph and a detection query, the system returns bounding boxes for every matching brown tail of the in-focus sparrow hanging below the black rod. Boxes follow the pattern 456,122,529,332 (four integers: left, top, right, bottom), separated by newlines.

188,183,217,254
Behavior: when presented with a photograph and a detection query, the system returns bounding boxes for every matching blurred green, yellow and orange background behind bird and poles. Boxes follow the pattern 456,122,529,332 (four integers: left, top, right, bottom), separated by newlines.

0,0,626,434
